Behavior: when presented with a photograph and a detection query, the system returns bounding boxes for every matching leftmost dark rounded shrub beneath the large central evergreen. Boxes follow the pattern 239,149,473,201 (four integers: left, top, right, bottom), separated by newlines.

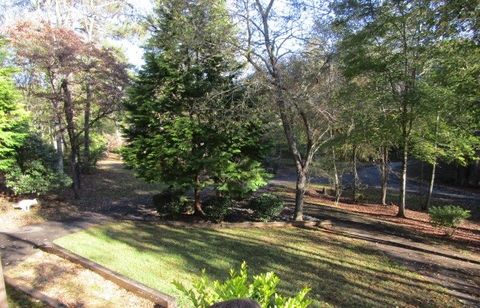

153,189,190,218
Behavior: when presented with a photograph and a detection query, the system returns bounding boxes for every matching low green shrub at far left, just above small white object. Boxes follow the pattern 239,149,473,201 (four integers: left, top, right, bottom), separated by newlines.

6,160,72,195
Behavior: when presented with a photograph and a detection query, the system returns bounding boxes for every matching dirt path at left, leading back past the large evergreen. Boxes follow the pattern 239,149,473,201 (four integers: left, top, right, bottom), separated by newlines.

0,157,161,267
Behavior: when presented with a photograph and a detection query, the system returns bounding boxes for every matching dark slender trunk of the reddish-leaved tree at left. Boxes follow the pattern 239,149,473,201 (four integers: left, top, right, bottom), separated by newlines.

62,79,80,198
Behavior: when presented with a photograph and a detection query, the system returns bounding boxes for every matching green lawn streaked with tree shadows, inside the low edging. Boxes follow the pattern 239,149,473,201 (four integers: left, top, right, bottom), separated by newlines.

55,222,461,307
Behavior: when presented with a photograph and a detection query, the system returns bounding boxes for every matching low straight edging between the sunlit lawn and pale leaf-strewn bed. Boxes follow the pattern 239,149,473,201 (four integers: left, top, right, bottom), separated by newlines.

38,243,176,308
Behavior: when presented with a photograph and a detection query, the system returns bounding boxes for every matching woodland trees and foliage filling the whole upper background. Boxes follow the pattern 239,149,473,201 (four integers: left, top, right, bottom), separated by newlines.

2,0,479,220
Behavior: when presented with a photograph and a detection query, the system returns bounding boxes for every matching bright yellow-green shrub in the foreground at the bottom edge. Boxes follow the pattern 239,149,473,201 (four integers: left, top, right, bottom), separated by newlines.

174,262,312,308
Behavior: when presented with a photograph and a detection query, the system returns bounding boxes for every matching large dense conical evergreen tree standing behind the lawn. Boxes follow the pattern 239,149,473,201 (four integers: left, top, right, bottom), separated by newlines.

124,0,266,214
